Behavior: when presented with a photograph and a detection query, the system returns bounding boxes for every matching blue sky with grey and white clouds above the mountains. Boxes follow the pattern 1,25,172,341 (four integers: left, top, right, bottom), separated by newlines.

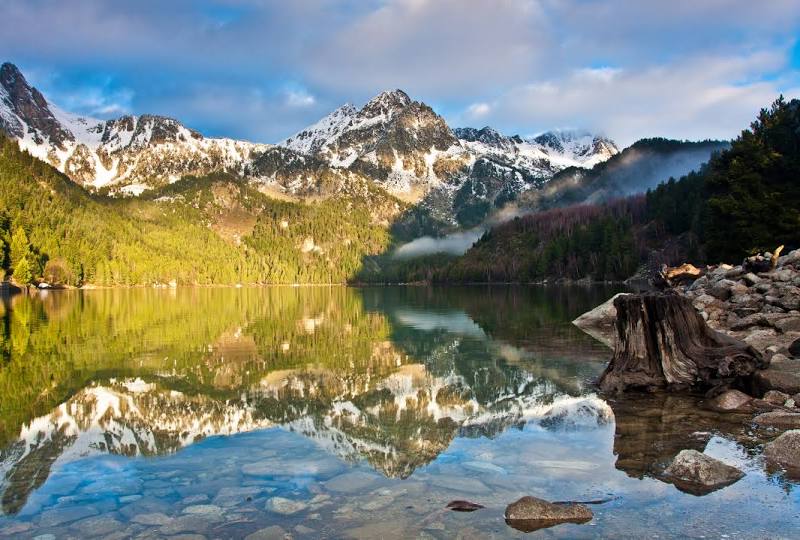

0,0,800,144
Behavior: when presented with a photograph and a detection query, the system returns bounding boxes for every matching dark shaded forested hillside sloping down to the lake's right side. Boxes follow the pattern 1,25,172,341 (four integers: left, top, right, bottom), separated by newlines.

418,98,800,282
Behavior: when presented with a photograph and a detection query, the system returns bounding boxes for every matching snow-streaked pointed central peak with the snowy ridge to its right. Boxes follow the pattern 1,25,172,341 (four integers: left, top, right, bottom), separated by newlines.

279,95,618,219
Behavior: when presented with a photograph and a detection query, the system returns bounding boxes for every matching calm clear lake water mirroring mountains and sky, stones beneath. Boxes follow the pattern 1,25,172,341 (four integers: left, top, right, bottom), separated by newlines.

0,287,800,538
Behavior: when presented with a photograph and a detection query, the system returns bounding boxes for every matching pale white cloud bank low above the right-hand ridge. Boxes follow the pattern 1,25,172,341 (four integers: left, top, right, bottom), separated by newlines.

462,51,793,144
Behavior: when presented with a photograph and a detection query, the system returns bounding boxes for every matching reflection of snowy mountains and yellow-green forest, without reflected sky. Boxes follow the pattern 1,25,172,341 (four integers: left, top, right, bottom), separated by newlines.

0,288,611,512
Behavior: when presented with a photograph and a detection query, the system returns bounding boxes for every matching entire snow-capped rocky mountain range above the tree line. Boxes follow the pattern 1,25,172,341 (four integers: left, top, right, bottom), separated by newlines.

0,63,619,227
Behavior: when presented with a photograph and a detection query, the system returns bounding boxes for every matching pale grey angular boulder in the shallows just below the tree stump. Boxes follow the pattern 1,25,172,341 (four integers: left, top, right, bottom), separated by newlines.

664,450,744,495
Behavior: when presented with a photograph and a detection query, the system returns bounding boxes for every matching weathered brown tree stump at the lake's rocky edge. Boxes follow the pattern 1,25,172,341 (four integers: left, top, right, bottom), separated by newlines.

599,292,767,392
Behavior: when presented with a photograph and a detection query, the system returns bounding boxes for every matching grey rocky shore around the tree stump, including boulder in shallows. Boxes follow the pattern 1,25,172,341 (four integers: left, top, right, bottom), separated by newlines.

574,250,800,494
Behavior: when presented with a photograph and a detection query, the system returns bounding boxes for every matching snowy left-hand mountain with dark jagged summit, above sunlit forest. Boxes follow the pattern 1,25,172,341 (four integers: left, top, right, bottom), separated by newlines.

0,63,269,194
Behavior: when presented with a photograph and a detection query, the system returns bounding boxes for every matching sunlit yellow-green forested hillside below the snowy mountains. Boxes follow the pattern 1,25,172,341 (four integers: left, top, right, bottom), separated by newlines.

0,135,400,286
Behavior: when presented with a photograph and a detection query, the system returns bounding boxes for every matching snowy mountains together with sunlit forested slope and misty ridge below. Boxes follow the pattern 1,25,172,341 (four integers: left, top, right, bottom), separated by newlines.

0,63,727,285
